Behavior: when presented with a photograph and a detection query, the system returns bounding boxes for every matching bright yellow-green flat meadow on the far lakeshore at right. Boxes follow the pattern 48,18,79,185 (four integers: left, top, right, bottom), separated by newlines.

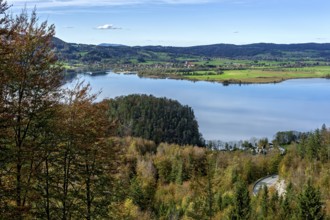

184,66,330,83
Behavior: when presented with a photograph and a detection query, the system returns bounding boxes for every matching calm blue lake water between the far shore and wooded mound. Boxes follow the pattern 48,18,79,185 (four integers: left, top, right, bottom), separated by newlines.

66,73,330,141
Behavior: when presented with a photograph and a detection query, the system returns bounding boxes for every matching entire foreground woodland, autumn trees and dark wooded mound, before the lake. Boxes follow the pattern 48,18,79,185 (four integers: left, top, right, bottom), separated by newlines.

0,0,330,220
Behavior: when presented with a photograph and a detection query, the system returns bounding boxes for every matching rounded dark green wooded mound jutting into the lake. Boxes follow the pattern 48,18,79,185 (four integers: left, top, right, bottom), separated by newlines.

109,95,204,146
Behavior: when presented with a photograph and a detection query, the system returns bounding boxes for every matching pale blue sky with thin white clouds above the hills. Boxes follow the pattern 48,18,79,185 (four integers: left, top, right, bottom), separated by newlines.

7,0,330,46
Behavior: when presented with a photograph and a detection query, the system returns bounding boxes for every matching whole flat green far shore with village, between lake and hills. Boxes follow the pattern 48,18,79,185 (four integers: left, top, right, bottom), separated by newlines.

62,52,330,83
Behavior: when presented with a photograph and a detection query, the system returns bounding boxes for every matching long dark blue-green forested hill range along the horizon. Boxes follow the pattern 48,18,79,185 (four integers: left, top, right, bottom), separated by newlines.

53,38,330,62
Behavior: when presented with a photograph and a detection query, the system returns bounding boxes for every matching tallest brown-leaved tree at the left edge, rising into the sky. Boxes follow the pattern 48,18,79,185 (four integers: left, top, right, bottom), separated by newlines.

0,5,62,219
